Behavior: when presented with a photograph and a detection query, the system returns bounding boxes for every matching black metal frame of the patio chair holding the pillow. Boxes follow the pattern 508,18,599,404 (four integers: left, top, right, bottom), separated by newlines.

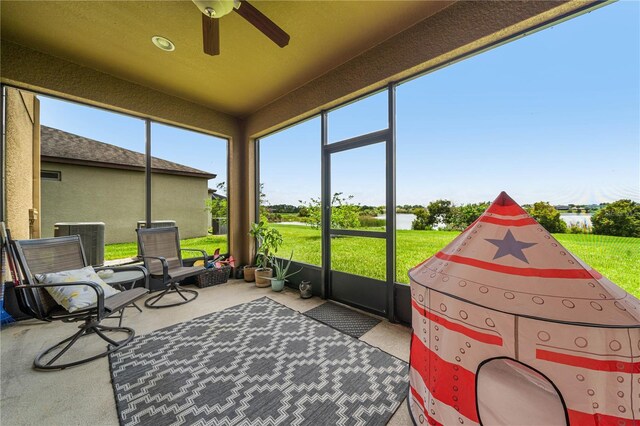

6,235,148,370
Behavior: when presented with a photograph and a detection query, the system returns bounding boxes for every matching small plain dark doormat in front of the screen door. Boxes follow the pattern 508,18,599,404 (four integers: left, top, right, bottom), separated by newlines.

303,302,380,339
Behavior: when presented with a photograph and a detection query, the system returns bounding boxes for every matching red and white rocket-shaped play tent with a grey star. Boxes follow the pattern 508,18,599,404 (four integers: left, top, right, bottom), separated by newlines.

408,192,640,426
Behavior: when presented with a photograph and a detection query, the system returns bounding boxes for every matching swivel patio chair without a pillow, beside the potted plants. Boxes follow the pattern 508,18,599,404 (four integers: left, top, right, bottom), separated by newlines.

136,226,207,309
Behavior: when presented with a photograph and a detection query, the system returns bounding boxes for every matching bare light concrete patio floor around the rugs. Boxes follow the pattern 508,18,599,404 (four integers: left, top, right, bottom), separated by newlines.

0,280,412,426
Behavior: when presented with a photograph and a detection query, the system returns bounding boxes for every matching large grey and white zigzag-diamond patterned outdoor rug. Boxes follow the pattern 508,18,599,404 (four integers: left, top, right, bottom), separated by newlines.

110,297,408,426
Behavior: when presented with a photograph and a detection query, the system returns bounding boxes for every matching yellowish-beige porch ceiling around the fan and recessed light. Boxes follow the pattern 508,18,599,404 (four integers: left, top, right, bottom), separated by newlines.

0,0,451,116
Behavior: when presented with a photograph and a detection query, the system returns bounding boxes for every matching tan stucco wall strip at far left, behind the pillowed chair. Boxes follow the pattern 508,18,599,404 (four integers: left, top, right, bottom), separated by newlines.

5,89,34,239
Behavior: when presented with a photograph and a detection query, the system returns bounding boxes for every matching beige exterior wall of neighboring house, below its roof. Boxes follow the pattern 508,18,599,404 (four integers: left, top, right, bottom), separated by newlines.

41,162,208,244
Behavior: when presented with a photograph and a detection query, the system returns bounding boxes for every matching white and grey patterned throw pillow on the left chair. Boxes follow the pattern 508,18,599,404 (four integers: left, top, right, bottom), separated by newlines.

35,266,119,312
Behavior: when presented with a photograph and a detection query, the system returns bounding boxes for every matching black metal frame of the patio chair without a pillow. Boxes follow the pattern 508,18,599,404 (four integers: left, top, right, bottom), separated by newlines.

136,226,207,309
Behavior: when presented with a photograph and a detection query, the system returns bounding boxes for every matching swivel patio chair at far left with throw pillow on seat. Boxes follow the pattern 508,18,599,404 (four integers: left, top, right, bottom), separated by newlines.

2,228,148,370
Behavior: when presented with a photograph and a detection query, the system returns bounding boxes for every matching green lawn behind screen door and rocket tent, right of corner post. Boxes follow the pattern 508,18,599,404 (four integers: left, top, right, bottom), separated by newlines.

274,225,640,297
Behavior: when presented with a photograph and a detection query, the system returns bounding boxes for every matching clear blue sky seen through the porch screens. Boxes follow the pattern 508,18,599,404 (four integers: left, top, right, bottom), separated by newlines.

41,1,640,205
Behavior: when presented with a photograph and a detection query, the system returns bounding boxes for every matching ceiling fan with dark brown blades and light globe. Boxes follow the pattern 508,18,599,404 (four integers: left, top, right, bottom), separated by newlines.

192,0,289,56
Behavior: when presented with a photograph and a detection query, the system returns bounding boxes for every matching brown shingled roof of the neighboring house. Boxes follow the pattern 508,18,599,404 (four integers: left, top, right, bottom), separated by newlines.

40,126,216,179
